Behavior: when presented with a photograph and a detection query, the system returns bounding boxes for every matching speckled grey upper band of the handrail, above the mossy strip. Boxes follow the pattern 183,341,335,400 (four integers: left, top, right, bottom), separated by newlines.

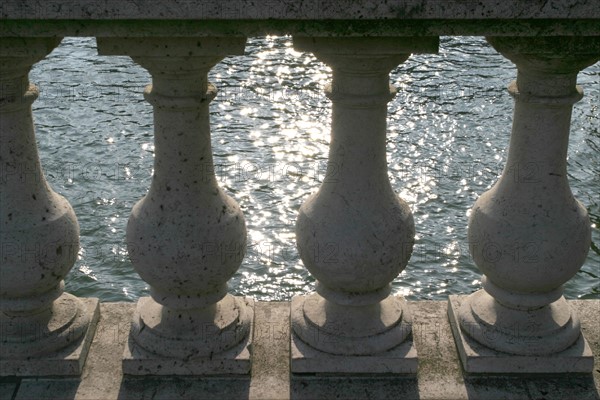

0,0,600,20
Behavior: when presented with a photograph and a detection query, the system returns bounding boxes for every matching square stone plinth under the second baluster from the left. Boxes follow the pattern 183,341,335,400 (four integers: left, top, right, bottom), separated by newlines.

123,298,254,376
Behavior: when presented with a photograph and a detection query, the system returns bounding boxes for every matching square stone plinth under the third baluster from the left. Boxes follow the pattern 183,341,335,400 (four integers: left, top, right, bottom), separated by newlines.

290,332,418,375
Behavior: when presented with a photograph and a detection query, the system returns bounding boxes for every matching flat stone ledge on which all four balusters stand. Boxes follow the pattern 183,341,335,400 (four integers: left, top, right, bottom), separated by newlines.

0,300,600,400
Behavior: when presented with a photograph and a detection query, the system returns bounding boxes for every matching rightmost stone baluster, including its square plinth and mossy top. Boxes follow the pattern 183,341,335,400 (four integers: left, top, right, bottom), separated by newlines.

449,37,600,373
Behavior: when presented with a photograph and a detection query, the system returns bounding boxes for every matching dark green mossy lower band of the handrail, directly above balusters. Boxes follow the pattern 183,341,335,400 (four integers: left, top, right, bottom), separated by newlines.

0,18,600,37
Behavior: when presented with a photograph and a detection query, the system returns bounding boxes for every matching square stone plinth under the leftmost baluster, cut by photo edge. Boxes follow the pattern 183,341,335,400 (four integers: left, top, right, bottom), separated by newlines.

0,298,100,376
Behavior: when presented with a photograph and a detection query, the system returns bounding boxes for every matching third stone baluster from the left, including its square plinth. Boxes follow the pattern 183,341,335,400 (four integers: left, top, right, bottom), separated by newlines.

291,37,438,373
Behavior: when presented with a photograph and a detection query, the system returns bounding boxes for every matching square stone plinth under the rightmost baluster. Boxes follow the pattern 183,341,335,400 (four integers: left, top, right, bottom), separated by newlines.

448,296,594,374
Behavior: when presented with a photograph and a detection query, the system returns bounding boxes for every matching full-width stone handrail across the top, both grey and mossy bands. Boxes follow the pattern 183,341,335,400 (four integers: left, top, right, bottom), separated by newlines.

0,0,600,37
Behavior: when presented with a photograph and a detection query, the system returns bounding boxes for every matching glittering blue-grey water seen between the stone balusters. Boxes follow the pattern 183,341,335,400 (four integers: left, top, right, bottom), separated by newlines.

31,37,600,301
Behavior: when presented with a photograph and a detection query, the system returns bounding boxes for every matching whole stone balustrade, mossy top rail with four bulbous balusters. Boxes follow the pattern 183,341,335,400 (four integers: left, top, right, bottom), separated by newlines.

0,0,600,375
